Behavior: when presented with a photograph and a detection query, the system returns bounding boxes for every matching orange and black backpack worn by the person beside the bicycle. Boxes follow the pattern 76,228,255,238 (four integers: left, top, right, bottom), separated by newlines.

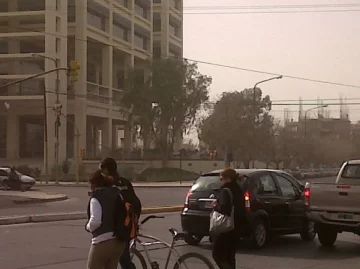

116,186,138,240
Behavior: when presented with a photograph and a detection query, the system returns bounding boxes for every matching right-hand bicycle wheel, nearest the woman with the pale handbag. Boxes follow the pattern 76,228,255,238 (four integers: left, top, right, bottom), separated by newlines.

174,252,215,269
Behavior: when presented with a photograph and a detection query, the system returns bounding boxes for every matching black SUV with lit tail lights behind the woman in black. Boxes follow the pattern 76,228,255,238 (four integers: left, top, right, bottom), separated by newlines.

181,169,316,248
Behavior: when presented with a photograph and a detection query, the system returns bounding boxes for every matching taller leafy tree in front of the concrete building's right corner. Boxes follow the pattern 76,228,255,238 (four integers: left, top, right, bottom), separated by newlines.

123,59,212,162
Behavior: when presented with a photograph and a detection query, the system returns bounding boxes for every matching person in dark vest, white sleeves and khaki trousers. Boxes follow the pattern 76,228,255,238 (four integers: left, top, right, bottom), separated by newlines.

86,170,127,269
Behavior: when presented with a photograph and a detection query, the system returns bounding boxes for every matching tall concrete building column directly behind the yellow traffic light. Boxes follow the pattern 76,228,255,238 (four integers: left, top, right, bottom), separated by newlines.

74,0,87,156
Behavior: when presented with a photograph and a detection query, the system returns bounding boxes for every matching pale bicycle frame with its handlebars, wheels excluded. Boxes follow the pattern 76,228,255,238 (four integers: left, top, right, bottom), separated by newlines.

130,230,187,269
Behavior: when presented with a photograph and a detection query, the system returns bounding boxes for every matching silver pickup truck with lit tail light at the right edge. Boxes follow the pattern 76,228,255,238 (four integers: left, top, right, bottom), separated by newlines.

304,160,360,246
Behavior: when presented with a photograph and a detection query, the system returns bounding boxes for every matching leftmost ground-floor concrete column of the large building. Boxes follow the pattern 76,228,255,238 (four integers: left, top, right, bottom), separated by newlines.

6,111,20,160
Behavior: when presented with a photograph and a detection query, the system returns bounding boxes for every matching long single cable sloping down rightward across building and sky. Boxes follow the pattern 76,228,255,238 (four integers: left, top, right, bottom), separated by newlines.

4,26,360,89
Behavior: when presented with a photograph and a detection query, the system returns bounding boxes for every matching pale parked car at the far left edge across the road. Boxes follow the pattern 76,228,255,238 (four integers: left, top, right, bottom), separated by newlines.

0,167,36,191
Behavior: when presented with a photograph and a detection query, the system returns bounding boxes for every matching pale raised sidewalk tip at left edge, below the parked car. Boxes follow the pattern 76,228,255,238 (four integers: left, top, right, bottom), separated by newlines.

0,191,68,204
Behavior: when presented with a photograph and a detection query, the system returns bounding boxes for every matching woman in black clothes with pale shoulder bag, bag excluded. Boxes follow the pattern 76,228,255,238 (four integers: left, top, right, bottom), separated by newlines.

212,168,245,269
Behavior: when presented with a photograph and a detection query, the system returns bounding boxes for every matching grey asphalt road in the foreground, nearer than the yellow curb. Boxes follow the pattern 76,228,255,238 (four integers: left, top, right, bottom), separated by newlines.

0,211,360,269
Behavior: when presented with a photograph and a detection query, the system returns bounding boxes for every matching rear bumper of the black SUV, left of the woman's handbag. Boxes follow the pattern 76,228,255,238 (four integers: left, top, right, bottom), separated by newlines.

181,209,210,236
